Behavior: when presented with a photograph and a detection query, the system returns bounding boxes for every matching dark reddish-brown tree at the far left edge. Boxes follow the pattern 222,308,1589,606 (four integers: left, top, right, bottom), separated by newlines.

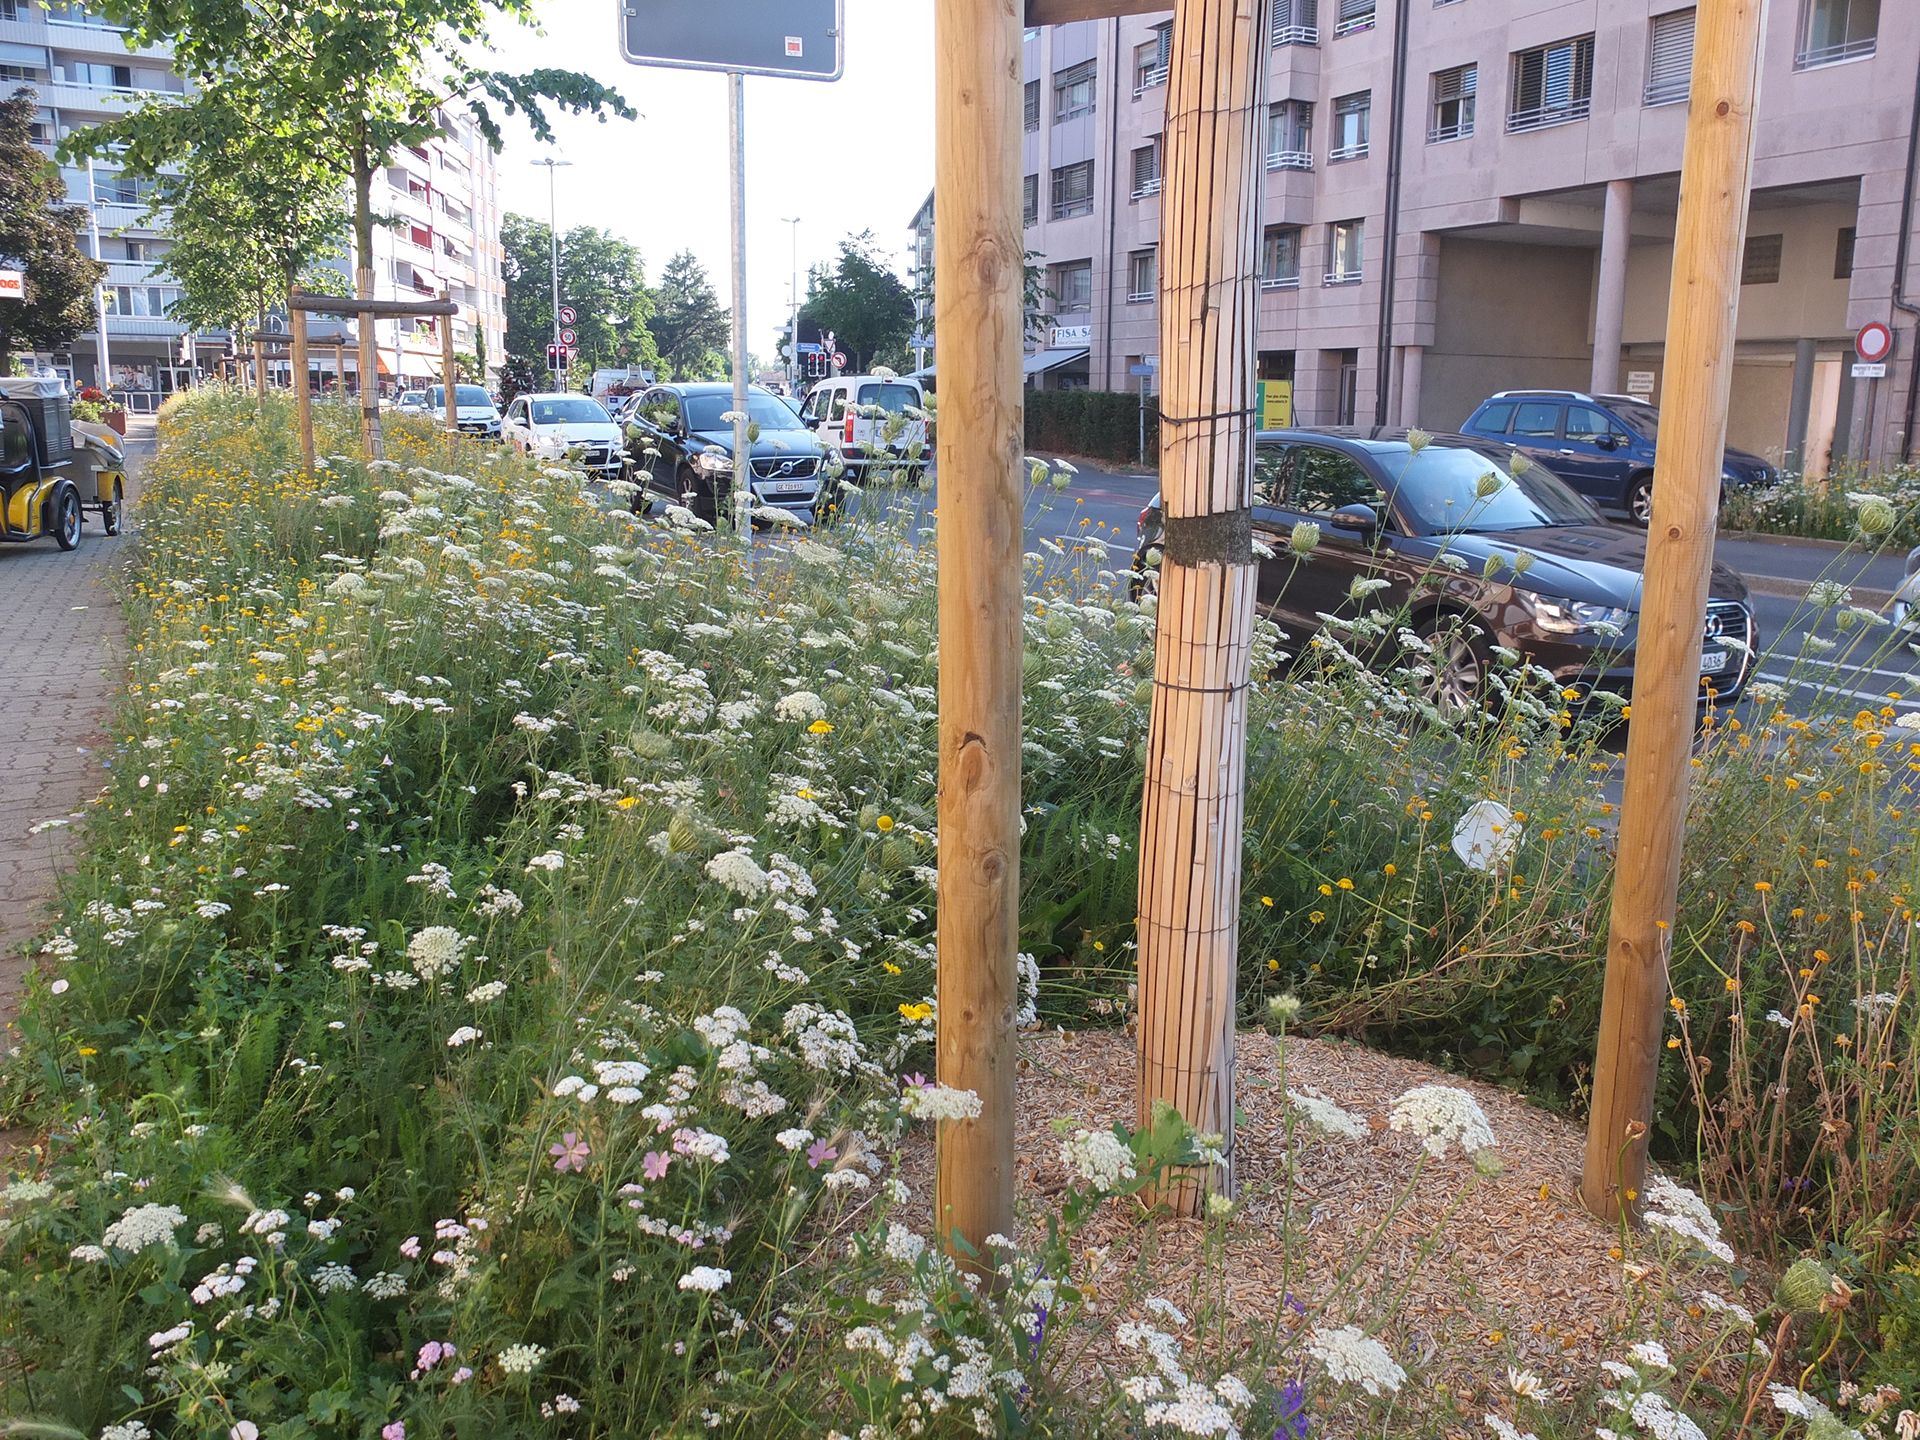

0,90,102,374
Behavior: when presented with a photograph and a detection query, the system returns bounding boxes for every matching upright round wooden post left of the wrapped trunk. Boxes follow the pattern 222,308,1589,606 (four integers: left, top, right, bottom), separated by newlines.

933,0,1025,1265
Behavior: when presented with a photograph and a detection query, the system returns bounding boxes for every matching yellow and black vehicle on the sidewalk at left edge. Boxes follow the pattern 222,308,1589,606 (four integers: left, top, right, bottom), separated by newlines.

0,376,127,549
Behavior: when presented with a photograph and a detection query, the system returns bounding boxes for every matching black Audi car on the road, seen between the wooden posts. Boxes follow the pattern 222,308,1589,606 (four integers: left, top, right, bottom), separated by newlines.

1133,428,1757,707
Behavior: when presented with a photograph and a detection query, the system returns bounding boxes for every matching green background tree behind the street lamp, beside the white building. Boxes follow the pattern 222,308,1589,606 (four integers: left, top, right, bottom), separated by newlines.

501,215,660,374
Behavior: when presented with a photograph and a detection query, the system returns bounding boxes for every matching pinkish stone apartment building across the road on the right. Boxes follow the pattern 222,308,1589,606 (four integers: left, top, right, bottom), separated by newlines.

998,0,1920,468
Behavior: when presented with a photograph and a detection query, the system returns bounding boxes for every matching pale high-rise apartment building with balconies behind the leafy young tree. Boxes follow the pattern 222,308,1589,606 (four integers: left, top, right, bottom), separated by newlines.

0,0,507,401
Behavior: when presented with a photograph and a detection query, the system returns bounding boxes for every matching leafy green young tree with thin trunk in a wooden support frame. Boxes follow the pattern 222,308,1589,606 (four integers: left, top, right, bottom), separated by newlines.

69,0,634,453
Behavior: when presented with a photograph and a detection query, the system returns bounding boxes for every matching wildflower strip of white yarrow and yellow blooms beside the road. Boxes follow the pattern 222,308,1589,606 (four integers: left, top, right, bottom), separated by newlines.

0,390,1920,1440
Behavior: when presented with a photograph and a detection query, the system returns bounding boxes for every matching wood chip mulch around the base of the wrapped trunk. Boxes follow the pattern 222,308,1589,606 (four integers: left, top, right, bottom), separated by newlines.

900,1031,1626,1415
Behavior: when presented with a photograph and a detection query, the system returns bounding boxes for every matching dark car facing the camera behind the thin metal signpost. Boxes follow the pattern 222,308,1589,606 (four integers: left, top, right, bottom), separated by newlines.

626,382,826,522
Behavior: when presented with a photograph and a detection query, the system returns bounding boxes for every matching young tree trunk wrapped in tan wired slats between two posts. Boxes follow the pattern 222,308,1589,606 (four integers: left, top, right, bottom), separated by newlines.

1128,0,1267,1213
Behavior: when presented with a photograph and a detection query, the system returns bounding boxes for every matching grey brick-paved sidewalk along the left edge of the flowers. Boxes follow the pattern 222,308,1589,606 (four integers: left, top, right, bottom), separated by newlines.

0,417,154,1043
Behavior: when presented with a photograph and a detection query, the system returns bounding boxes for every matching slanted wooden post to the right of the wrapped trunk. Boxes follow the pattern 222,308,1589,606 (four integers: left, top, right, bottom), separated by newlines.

1580,0,1766,1217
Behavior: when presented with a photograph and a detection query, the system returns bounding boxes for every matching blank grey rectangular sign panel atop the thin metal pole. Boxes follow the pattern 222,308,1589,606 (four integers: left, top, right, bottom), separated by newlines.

618,0,847,81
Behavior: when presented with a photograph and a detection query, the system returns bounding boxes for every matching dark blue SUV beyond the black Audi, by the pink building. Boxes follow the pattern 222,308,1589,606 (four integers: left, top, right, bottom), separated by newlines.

1461,390,1780,524
